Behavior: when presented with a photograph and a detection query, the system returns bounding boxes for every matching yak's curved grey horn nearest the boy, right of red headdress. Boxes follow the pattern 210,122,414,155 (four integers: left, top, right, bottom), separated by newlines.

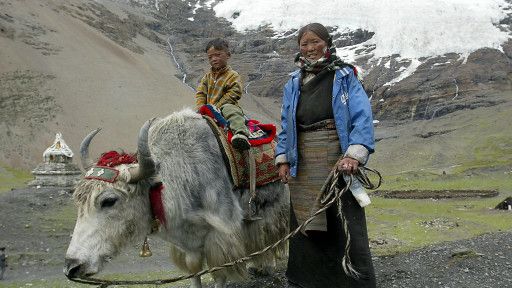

130,118,156,183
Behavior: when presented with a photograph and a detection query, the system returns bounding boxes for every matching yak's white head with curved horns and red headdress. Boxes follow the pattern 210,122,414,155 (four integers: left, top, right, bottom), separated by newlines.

64,122,155,278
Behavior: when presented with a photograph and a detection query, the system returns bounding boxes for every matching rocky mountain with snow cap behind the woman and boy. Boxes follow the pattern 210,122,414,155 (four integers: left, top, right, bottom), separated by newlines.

152,0,512,120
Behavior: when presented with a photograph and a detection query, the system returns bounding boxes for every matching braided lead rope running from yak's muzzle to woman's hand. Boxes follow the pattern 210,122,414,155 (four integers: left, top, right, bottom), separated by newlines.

69,166,382,288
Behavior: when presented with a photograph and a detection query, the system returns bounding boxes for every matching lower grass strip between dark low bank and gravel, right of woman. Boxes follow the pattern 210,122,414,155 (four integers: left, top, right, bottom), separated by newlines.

366,197,512,255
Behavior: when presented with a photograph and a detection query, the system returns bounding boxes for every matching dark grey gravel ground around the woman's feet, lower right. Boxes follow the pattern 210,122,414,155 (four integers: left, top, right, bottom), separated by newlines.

221,232,512,288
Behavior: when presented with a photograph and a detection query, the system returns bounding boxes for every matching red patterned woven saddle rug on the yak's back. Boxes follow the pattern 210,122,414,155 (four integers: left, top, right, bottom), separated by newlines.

199,105,279,188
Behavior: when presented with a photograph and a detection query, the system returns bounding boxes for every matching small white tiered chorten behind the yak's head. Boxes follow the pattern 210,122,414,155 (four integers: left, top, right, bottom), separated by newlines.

28,133,81,188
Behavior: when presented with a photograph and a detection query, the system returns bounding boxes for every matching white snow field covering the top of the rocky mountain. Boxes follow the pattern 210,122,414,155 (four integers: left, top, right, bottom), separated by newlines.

213,0,512,80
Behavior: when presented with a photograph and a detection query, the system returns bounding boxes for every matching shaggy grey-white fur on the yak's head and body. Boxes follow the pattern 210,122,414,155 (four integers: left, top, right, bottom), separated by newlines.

66,109,289,287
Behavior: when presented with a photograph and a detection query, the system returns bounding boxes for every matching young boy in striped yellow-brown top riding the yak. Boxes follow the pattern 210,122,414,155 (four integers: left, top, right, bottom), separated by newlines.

196,38,251,150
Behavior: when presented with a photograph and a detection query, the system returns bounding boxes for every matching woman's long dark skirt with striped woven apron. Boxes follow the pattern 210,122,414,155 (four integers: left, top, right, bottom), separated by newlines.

286,130,376,288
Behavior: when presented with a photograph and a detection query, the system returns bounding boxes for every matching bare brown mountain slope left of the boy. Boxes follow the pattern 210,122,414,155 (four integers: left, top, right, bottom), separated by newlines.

0,0,193,168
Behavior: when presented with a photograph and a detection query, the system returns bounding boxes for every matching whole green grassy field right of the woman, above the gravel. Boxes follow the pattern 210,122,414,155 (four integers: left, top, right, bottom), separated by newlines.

366,151,512,255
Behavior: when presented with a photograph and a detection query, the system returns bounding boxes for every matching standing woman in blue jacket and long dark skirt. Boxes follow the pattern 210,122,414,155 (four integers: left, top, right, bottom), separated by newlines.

276,23,375,288
